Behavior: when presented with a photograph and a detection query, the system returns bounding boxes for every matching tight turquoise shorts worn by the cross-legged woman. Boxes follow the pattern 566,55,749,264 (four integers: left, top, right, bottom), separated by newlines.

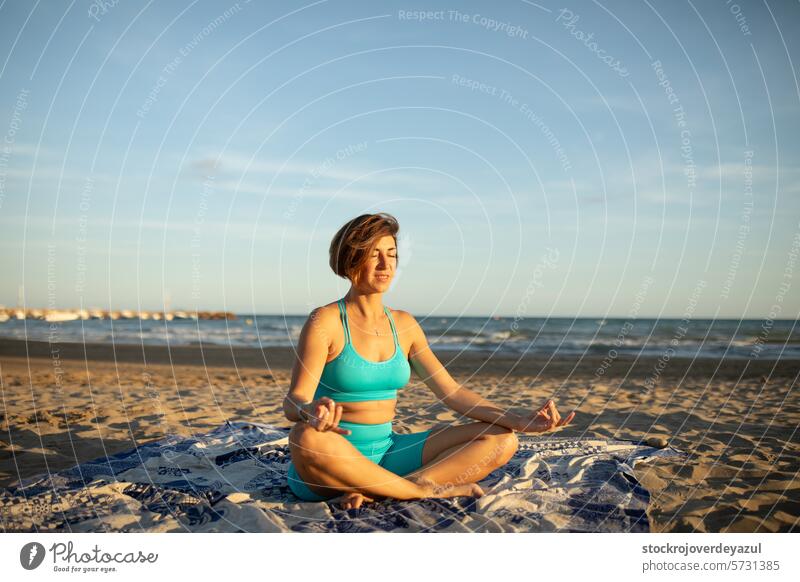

287,420,431,501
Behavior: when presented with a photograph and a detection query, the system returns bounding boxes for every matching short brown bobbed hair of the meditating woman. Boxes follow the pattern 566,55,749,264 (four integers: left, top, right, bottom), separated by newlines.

329,212,400,285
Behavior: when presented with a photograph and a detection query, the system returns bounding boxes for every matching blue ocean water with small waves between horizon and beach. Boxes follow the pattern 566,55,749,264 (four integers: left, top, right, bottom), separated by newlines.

0,314,800,360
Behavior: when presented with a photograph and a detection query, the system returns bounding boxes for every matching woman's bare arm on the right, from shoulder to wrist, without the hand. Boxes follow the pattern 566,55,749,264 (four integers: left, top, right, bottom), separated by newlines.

401,311,524,430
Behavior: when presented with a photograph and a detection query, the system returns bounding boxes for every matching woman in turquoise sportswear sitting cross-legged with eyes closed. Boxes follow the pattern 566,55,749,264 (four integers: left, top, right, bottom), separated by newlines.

283,213,575,509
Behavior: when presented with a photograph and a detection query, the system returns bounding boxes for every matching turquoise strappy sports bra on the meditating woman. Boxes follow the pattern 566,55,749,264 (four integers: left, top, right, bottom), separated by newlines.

314,299,411,402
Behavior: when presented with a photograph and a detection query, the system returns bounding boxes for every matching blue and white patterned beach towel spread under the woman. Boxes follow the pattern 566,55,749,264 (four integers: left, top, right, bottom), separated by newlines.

0,421,685,532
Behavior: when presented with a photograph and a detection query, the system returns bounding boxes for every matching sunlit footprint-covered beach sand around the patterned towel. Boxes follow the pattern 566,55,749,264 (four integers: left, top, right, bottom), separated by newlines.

0,340,800,532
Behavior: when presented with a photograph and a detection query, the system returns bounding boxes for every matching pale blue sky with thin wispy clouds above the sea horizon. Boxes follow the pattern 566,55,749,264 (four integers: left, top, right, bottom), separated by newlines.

0,0,800,319
